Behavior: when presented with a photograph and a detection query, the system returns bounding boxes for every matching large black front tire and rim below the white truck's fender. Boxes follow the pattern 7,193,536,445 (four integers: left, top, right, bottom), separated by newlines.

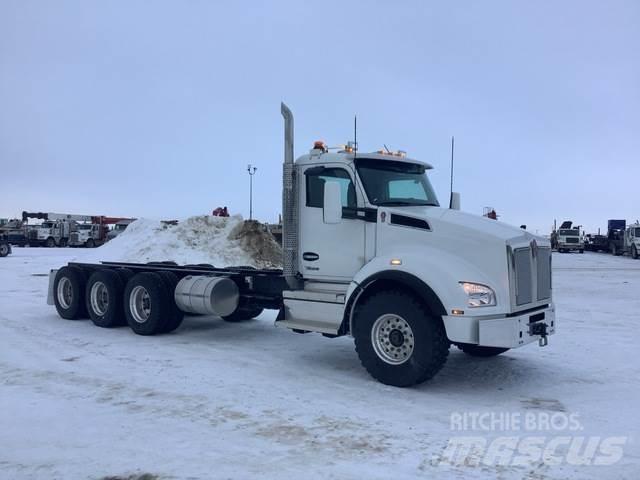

353,291,449,387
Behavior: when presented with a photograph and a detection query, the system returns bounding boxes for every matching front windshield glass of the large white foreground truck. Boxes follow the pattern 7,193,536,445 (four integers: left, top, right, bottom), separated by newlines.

356,158,440,207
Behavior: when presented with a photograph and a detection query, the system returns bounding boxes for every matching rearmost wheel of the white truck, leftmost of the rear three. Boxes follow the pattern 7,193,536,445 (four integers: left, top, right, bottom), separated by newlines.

53,267,87,320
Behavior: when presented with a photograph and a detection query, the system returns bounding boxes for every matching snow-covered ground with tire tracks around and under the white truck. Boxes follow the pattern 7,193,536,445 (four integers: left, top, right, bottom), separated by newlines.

0,248,640,479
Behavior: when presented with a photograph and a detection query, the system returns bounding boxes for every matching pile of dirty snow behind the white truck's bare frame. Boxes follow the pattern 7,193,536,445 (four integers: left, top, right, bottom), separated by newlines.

91,215,282,268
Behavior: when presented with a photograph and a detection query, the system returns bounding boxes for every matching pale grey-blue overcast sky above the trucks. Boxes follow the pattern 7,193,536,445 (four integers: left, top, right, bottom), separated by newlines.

0,0,640,233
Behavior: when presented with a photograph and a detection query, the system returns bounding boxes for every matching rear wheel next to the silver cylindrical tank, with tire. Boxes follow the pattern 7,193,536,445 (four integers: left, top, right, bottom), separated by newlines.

124,272,170,335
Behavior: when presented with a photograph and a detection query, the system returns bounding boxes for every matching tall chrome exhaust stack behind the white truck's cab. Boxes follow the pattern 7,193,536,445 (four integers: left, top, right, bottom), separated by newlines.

280,103,302,290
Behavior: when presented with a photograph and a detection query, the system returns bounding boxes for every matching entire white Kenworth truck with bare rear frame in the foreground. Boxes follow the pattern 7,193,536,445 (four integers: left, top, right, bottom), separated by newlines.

49,104,556,387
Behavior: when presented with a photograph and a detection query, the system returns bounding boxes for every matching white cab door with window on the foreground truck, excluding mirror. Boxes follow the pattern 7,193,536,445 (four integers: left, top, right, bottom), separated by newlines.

299,164,365,282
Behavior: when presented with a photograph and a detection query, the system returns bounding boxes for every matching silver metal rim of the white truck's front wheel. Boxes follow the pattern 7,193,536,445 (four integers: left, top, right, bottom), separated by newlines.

371,313,415,365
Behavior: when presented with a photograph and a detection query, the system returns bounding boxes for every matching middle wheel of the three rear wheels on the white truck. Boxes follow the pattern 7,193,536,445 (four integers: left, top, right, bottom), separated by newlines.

85,270,126,328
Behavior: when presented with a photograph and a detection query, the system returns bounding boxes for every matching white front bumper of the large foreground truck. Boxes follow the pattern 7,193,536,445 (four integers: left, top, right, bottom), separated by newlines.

442,304,556,348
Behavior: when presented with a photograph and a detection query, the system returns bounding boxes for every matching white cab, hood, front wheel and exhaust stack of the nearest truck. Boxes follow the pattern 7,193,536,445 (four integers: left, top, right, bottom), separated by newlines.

276,103,552,385
